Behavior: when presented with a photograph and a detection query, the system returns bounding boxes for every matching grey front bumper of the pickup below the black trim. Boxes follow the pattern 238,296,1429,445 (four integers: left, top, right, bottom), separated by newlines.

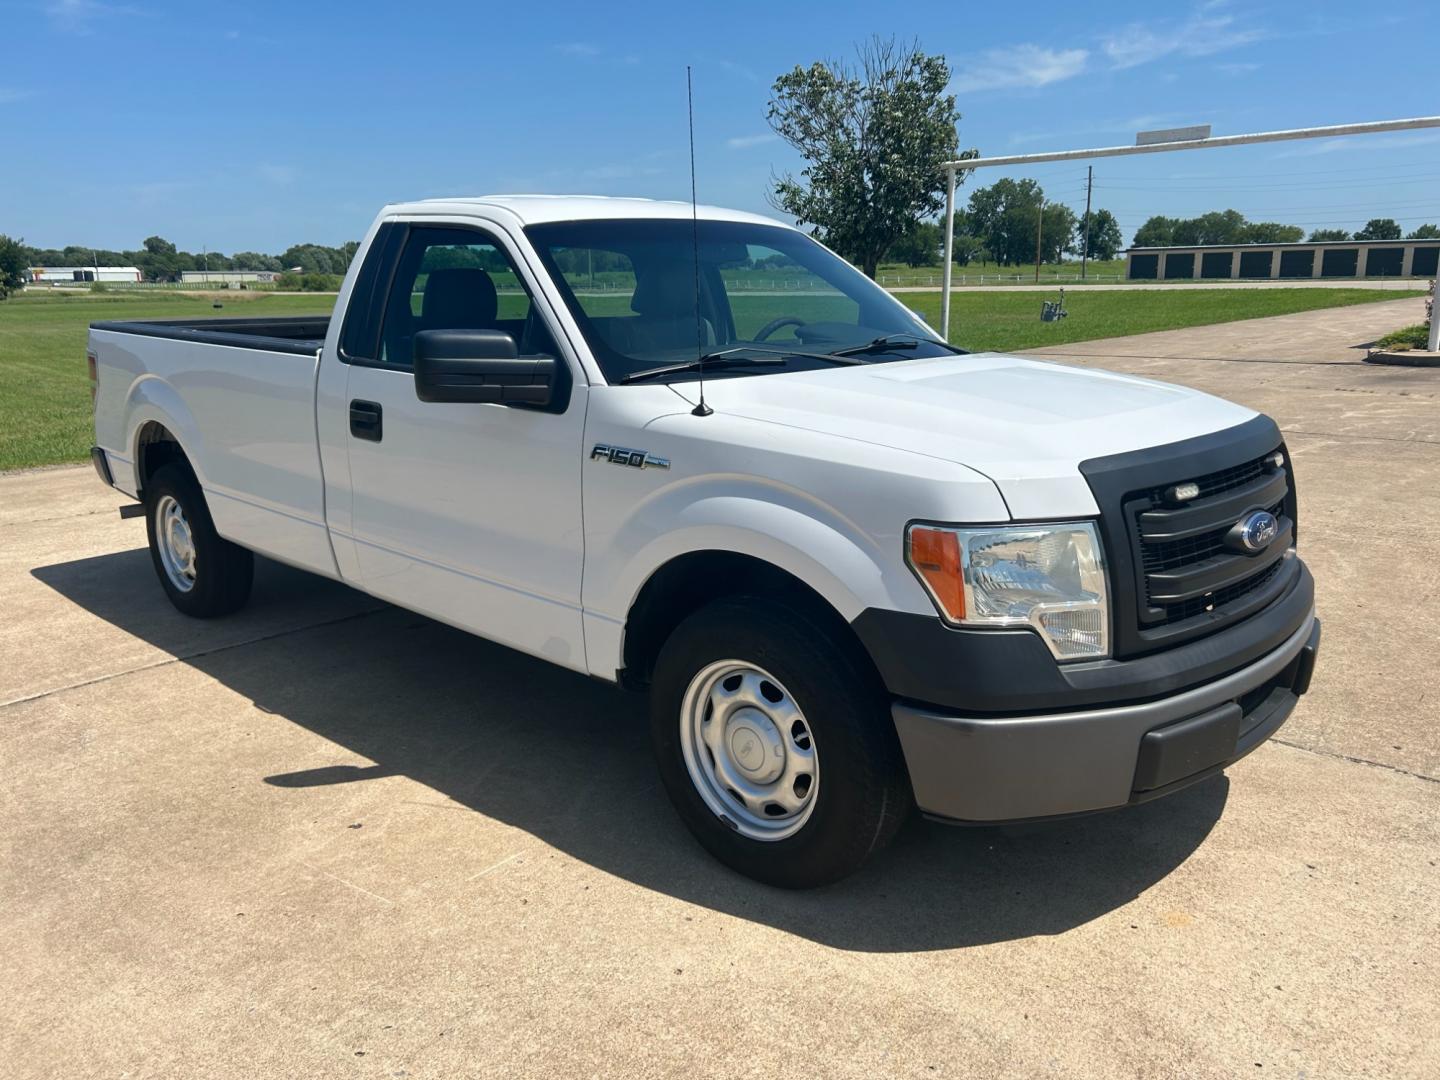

891,608,1320,824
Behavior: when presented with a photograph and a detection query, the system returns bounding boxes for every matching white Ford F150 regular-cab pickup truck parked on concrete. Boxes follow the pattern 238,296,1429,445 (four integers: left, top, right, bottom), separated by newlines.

89,196,1319,887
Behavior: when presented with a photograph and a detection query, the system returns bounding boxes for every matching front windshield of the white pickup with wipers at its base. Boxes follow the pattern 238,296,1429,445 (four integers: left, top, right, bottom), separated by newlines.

526,219,955,383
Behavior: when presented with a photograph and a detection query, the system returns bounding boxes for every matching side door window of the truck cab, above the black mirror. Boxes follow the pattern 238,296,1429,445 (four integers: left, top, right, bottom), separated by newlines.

380,226,556,369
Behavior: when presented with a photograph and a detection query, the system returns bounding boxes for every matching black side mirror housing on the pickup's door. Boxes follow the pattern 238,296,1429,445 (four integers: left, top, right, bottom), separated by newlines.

415,330,556,405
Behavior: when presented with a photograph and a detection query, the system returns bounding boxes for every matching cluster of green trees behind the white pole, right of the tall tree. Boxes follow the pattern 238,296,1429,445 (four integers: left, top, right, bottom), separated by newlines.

888,179,1125,266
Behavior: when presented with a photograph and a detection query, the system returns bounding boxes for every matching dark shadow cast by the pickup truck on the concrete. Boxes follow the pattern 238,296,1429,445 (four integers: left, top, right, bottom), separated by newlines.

32,552,1228,952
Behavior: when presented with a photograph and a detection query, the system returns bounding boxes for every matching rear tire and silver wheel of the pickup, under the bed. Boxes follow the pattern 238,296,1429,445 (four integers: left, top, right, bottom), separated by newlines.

145,462,255,619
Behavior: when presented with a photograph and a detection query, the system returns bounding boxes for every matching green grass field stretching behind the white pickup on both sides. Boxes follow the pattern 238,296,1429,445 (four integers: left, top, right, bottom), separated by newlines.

0,288,1420,469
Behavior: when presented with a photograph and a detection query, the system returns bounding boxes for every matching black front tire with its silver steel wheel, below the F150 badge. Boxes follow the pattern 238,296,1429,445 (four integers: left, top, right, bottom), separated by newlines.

651,598,913,888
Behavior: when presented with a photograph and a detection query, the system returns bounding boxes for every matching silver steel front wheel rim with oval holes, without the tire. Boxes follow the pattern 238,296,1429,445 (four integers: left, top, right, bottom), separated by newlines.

680,660,819,840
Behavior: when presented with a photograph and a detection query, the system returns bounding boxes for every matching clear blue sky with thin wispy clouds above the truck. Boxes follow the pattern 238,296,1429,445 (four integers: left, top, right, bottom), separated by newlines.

0,0,1440,252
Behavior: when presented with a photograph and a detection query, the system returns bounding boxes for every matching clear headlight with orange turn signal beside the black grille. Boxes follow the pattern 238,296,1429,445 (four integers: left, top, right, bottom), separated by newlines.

906,521,1110,660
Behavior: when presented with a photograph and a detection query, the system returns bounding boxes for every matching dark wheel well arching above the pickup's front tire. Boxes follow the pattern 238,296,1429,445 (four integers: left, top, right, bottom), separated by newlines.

616,552,878,690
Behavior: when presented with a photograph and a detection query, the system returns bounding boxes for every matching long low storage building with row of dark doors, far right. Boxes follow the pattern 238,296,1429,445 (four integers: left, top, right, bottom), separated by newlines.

1125,240,1440,281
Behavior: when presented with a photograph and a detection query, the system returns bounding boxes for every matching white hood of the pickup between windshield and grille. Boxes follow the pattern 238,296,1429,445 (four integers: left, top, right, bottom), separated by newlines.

691,353,1256,518
